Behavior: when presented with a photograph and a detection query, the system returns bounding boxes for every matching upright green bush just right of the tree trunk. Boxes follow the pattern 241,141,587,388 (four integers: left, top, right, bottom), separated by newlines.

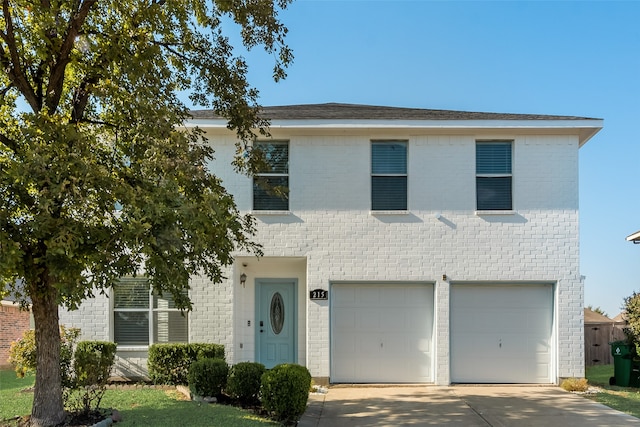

65,341,117,414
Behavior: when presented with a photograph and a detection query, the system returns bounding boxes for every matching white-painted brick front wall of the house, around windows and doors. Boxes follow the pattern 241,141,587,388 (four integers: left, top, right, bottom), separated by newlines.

63,129,584,384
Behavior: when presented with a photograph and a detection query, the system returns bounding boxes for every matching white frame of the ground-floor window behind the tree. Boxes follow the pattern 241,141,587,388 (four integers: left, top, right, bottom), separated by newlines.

109,277,191,350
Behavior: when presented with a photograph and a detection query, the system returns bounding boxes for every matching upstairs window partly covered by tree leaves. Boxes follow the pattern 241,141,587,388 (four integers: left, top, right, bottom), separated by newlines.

253,142,289,211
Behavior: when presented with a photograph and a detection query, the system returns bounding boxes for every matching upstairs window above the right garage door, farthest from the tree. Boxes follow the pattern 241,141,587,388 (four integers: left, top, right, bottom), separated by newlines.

476,141,513,211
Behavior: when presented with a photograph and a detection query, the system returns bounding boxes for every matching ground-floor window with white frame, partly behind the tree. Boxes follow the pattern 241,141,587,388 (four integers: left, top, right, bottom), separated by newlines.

113,278,189,346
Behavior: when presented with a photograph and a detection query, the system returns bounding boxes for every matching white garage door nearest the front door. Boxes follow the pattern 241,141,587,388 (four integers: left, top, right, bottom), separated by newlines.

331,284,433,383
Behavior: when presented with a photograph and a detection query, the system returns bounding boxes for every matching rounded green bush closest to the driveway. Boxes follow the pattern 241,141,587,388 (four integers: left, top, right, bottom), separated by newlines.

260,363,311,423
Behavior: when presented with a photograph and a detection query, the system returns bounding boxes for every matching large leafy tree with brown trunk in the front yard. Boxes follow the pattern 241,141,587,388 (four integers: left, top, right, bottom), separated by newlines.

0,0,292,426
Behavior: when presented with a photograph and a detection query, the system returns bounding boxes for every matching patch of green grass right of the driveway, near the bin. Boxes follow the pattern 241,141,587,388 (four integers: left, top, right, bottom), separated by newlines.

585,365,640,418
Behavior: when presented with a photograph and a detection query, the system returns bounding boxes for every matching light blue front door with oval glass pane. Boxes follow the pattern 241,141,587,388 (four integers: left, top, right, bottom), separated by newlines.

256,279,297,369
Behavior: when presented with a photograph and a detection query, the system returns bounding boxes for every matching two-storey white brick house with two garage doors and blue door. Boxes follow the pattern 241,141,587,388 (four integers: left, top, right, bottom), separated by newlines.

61,104,602,385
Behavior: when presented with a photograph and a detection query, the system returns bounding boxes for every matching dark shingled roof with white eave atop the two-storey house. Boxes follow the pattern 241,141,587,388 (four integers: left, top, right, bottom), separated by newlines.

189,103,603,146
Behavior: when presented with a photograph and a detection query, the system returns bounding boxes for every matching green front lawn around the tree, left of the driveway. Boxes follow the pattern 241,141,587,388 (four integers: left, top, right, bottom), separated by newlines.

0,370,278,427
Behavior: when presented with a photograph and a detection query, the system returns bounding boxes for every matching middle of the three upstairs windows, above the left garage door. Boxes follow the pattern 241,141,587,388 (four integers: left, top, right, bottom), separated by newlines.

371,141,407,211
